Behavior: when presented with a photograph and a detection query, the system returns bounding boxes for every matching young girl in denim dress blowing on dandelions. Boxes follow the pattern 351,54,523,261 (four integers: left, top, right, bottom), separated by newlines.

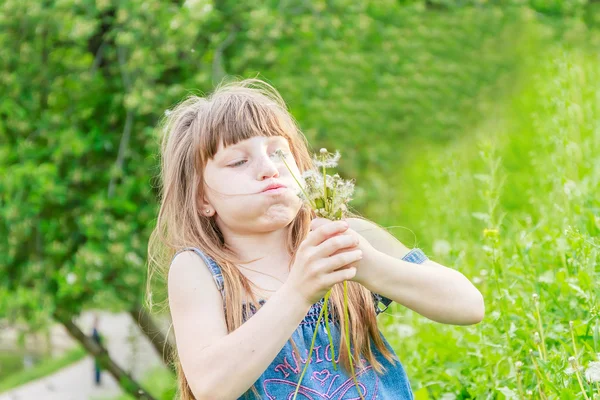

150,79,484,400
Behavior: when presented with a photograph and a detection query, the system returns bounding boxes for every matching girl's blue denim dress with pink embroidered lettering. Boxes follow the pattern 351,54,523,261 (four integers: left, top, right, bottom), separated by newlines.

171,247,428,400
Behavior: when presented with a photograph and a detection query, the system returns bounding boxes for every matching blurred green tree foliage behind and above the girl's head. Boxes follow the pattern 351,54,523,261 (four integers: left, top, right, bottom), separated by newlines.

0,0,596,396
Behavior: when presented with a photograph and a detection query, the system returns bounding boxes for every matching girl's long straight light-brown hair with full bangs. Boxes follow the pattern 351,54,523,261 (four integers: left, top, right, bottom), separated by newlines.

147,79,397,400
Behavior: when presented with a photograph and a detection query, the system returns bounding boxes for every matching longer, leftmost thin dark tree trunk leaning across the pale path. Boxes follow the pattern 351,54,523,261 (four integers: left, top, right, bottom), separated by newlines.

54,312,154,400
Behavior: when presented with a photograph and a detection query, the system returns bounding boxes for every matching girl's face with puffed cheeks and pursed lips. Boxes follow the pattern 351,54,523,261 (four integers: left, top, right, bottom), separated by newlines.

202,136,302,233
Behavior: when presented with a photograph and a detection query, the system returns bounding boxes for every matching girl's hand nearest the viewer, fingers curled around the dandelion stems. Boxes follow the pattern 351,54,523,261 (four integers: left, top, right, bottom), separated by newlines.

286,221,362,305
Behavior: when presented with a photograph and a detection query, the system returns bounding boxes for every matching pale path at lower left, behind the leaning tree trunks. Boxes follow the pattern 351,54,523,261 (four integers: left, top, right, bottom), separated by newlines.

0,311,161,400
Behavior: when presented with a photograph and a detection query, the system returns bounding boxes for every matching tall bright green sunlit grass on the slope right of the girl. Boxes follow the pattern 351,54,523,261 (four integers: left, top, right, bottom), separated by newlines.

385,26,600,399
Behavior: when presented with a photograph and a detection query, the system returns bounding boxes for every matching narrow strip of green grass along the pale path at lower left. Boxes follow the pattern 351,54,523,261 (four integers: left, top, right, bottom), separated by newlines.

0,347,87,393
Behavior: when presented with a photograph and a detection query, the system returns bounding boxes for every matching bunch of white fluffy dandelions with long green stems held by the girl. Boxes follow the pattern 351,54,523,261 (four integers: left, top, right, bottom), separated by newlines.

277,149,364,400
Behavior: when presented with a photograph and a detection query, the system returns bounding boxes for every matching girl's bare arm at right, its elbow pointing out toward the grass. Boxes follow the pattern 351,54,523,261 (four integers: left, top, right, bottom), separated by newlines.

348,218,485,325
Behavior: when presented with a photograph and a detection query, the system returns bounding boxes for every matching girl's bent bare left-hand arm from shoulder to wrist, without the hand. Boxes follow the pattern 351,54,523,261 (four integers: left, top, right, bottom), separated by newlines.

168,252,311,400
